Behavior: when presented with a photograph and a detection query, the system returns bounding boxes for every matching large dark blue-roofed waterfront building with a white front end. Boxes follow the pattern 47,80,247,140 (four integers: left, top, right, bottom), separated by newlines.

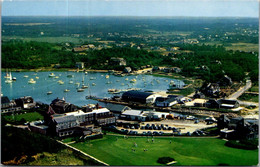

122,90,161,104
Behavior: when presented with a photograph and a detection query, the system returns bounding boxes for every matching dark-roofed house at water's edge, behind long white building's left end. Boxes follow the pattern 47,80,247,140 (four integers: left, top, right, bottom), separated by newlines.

50,98,77,114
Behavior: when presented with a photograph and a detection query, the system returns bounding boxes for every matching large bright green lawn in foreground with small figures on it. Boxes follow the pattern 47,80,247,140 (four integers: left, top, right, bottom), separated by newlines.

71,135,258,166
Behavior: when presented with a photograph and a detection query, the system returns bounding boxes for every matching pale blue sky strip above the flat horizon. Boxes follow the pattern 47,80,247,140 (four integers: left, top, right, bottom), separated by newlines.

1,0,259,18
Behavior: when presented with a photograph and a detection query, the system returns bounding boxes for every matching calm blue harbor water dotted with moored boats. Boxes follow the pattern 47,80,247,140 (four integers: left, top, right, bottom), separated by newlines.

1,72,184,106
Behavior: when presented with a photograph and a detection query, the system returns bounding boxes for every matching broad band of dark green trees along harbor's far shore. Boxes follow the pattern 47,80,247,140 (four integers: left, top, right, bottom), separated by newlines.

2,41,258,82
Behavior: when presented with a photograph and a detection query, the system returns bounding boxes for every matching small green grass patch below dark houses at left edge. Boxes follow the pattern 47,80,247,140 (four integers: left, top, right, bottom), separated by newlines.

4,112,43,122
